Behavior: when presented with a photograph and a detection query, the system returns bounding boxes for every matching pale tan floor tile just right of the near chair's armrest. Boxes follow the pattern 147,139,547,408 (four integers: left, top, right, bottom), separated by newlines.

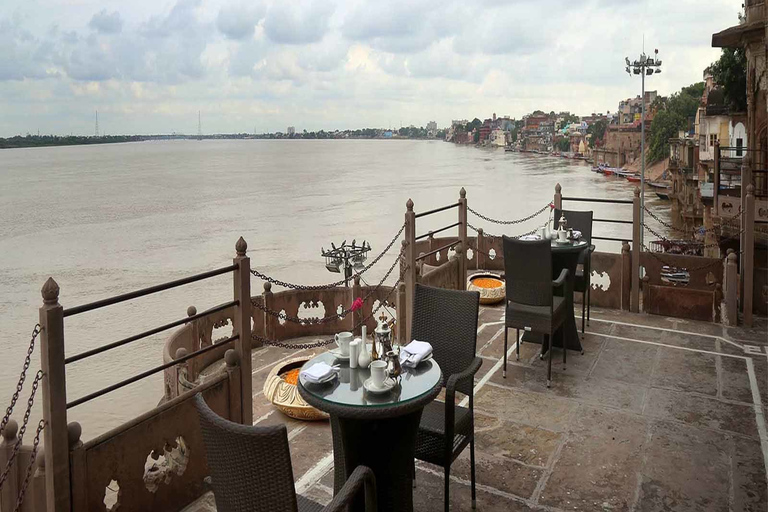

475,386,578,432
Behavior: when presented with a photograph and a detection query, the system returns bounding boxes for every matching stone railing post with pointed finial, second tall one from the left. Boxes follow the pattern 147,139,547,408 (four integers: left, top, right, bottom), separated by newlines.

232,237,253,425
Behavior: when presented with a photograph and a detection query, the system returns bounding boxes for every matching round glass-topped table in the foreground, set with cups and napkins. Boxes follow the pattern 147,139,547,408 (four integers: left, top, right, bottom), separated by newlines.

298,352,442,512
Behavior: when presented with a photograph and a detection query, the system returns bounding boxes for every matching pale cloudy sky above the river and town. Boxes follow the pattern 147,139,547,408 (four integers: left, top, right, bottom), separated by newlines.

0,0,742,136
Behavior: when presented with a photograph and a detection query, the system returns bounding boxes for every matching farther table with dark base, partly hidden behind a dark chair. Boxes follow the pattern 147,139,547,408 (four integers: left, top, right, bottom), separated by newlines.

522,240,589,354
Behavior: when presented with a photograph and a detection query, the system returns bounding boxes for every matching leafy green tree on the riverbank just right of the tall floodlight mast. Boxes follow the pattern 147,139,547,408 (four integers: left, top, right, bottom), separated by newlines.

648,82,704,162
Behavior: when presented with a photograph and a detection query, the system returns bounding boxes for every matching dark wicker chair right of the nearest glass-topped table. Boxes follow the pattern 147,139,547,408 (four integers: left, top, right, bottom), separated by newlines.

411,284,483,511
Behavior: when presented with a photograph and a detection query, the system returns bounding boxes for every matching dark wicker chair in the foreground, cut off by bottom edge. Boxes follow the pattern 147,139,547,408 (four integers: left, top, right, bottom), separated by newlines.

194,393,376,512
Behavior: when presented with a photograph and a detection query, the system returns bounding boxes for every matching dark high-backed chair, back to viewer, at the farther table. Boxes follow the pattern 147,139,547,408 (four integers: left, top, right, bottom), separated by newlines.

502,236,569,387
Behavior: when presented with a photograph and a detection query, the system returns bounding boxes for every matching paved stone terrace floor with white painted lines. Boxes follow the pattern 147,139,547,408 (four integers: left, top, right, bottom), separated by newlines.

187,308,768,512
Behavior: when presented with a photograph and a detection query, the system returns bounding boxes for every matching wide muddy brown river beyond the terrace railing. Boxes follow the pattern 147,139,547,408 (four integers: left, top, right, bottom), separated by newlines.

0,140,665,438
